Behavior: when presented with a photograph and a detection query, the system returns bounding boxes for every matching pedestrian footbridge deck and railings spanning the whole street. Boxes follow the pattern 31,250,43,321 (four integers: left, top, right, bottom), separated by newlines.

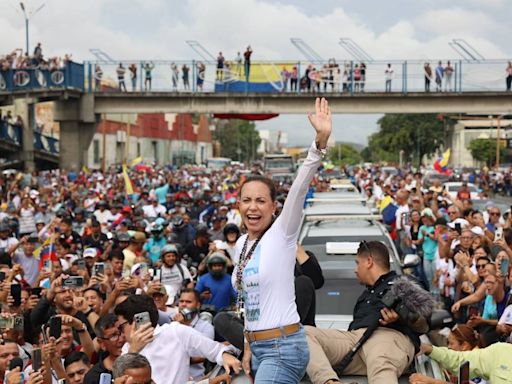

0,60,512,114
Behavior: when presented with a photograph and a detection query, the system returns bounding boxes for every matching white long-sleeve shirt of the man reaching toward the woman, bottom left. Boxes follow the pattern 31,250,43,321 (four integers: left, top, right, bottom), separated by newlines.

122,321,235,384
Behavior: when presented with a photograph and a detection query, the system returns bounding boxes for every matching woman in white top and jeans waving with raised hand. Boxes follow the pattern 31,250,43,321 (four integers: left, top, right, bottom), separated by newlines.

232,98,332,384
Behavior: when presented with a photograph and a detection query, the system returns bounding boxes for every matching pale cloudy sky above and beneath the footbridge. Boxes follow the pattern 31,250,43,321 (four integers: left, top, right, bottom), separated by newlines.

0,0,512,145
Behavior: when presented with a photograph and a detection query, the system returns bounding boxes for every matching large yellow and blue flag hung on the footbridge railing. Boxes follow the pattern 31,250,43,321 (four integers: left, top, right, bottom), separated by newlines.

215,62,299,93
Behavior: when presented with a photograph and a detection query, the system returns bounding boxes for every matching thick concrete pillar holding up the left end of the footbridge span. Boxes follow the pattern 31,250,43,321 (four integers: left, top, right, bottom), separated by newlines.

59,120,96,171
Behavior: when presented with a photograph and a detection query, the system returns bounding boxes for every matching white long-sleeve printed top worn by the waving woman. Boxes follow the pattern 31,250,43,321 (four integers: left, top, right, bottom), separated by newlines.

231,144,321,331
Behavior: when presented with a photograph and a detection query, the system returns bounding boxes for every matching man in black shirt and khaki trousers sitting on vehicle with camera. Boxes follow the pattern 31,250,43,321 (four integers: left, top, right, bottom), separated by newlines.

306,241,428,384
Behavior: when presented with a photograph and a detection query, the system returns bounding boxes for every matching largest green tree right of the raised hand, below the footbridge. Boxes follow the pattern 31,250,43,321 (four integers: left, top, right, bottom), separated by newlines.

368,114,444,162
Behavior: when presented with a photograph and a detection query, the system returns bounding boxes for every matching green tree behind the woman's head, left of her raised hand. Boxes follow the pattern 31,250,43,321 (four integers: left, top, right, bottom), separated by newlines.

213,120,261,162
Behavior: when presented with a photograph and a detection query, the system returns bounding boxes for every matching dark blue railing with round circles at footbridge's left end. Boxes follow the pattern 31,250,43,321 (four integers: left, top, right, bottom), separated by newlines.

0,62,85,91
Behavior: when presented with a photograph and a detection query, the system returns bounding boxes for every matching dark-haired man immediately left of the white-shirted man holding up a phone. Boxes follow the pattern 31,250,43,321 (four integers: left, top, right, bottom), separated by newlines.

84,313,126,384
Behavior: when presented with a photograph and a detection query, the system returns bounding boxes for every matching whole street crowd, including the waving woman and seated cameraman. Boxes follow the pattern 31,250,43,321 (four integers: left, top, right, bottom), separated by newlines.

0,100,512,384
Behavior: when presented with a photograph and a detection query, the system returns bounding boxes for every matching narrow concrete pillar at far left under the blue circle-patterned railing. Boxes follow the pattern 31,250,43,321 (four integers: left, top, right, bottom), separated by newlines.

14,99,36,172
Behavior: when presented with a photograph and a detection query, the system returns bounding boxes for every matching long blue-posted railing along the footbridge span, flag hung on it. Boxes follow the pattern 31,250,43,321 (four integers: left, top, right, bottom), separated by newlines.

84,59,508,94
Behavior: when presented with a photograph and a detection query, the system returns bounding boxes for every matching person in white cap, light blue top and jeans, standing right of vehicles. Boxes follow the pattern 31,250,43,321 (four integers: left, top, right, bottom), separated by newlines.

418,208,437,292
